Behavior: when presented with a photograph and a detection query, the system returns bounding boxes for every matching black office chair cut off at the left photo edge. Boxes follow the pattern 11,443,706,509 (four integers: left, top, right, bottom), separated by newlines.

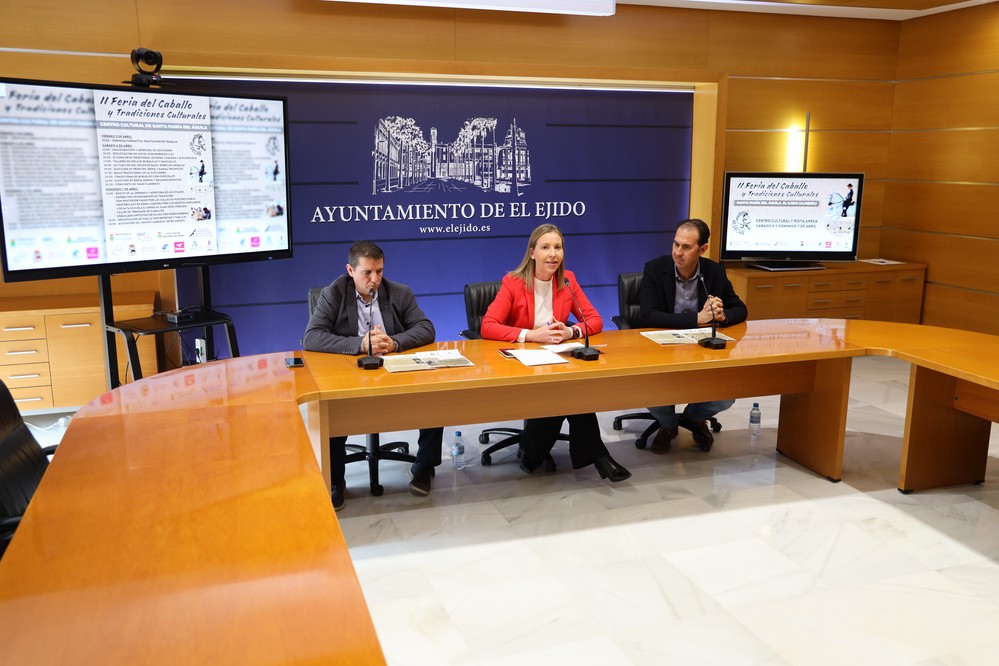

0,382,56,558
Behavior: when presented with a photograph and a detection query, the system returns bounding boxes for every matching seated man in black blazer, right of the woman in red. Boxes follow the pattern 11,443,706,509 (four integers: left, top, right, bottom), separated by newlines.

639,219,748,453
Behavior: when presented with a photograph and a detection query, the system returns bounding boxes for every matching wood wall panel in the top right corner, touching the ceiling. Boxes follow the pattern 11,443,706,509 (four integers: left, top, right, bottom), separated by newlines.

898,3,999,80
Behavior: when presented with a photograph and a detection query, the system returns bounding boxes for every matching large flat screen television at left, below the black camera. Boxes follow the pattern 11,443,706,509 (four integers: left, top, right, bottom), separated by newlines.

0,78,292,282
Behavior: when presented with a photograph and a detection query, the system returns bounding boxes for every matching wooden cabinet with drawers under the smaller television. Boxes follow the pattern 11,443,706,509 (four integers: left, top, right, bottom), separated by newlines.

727,261,926,324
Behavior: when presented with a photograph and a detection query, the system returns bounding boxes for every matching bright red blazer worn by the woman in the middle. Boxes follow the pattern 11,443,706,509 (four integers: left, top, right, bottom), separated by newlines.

481,270,604,342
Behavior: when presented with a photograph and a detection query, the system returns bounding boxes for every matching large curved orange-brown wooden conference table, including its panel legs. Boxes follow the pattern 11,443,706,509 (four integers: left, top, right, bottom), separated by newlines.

0,319,999,664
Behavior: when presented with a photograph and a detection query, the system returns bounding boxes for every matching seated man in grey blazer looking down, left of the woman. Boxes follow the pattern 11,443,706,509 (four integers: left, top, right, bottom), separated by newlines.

302,241,444,511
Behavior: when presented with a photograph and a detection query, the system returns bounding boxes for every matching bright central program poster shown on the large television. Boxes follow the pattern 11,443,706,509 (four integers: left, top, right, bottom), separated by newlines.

93,90,217,263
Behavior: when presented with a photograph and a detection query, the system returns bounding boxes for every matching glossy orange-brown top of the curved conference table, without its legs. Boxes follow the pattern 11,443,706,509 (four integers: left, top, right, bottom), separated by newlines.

0,319,999,665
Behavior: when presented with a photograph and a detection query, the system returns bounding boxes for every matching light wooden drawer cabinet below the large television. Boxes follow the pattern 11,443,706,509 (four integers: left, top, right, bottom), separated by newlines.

0,292,156,410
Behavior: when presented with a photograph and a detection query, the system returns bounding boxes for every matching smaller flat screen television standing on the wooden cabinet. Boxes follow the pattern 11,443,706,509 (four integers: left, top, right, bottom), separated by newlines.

720,172,864,270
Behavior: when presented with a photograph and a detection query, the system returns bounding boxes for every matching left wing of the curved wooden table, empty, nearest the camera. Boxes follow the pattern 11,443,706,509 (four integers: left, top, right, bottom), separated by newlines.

0,354,384,666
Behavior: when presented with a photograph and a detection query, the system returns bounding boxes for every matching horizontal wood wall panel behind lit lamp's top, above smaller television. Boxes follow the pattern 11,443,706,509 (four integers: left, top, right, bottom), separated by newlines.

728,77,894,130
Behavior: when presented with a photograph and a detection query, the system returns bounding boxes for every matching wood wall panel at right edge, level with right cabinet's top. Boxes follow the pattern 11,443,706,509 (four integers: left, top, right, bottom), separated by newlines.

881,227,999,292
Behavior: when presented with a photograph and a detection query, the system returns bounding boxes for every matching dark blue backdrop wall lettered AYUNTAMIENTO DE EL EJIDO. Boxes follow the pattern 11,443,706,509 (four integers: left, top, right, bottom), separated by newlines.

172,81,693,354
